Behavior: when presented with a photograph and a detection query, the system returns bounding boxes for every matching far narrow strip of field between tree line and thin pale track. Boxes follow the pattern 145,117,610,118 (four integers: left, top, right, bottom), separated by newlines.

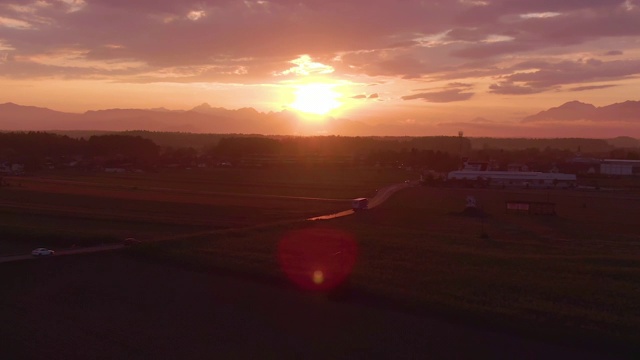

23,167,410,199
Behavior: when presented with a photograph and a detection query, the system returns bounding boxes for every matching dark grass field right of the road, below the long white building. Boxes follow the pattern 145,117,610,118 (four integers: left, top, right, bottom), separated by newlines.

131,187,640,345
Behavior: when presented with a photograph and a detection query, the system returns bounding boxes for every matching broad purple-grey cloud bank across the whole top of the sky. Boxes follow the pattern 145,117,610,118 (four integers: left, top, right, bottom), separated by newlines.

0,0,640,89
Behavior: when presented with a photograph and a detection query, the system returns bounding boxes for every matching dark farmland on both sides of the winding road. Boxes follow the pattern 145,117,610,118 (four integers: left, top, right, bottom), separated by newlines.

0,169,640,356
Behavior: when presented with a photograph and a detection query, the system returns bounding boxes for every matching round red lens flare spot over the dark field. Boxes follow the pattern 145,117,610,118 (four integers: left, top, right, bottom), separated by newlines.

278,228,358,291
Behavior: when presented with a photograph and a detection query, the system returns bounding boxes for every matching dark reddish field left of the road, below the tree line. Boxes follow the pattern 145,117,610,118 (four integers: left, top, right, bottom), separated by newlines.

0,168,407,254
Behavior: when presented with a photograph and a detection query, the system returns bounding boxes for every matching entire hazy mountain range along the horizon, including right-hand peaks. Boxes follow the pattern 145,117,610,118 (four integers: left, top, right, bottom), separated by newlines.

0,101,640,136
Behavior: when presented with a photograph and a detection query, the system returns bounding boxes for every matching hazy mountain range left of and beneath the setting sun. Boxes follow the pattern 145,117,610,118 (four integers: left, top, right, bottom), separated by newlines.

0,103,370,135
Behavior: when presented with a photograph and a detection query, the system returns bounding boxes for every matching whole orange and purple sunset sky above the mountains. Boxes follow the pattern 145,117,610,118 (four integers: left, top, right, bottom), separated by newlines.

0,0,640,136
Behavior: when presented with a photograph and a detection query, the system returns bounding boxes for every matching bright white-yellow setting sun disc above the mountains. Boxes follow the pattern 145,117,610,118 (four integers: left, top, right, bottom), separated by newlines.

290,84,342,115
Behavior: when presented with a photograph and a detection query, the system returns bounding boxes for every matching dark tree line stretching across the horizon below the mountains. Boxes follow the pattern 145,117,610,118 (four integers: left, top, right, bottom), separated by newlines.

0,132,640,172
